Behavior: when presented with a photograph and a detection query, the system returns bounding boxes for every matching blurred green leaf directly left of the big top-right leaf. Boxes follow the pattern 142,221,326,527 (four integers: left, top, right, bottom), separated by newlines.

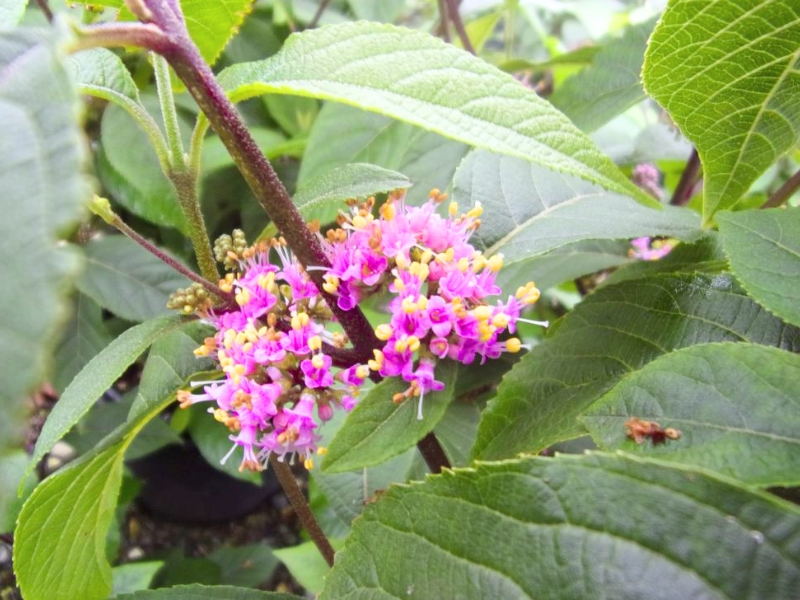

550,18,656,131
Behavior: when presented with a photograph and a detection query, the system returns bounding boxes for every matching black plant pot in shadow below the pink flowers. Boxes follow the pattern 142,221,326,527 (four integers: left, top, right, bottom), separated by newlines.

127,440,280,523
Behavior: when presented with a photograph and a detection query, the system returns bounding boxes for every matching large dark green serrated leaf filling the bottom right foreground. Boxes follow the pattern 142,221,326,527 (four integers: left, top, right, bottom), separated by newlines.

319,454,800,600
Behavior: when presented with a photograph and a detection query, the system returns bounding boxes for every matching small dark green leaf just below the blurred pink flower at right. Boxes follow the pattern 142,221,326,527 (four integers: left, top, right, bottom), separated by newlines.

600,231,728,286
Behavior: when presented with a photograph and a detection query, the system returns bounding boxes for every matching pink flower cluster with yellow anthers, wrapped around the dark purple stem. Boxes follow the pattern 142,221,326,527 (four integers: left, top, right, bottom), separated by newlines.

178,190,539,470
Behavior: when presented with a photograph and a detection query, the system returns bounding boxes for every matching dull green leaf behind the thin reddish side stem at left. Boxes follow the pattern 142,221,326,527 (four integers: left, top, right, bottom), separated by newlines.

78,235,190,321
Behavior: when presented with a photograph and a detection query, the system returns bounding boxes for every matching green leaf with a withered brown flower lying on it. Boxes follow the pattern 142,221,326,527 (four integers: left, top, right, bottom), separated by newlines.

581,343,800,487
